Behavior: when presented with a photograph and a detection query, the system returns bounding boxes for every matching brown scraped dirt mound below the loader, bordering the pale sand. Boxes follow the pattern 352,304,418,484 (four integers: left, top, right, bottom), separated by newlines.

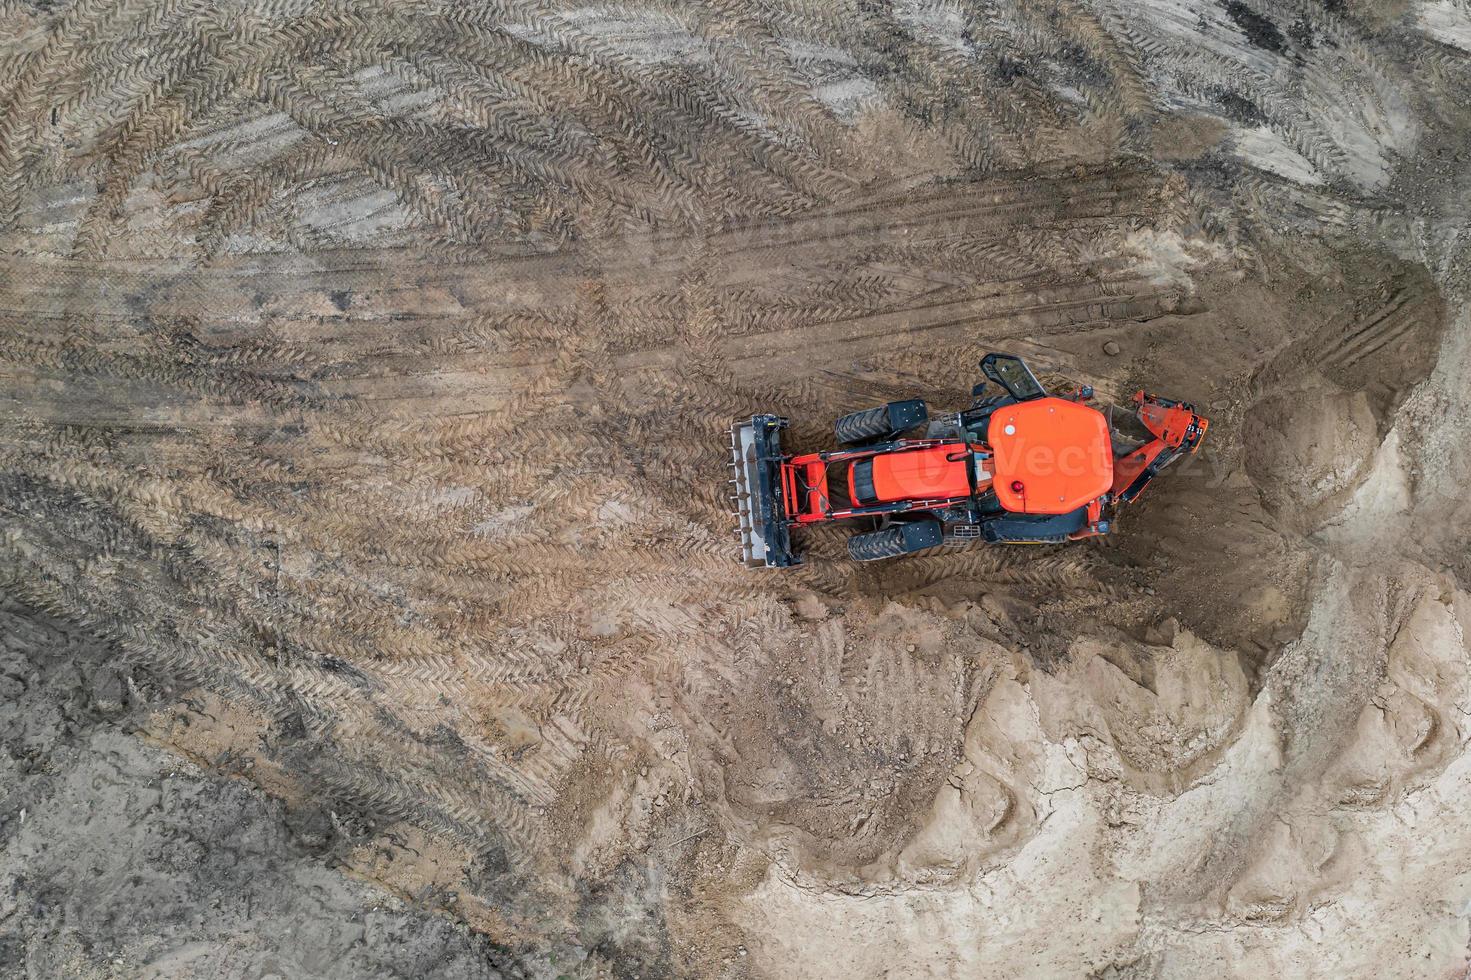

683,603,1005,886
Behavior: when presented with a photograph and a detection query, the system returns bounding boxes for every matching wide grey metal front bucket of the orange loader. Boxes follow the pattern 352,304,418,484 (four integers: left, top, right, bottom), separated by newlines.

731,415,797,568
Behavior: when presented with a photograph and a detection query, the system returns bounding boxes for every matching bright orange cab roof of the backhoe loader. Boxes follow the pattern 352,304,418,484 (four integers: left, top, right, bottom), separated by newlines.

987,397,1114,514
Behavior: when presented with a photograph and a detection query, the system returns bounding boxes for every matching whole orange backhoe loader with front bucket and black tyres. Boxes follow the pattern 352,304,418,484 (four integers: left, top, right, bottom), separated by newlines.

731,353,1209,568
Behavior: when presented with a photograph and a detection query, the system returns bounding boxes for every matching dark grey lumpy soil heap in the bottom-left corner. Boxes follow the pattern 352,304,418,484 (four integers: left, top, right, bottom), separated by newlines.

0,603,519,980
